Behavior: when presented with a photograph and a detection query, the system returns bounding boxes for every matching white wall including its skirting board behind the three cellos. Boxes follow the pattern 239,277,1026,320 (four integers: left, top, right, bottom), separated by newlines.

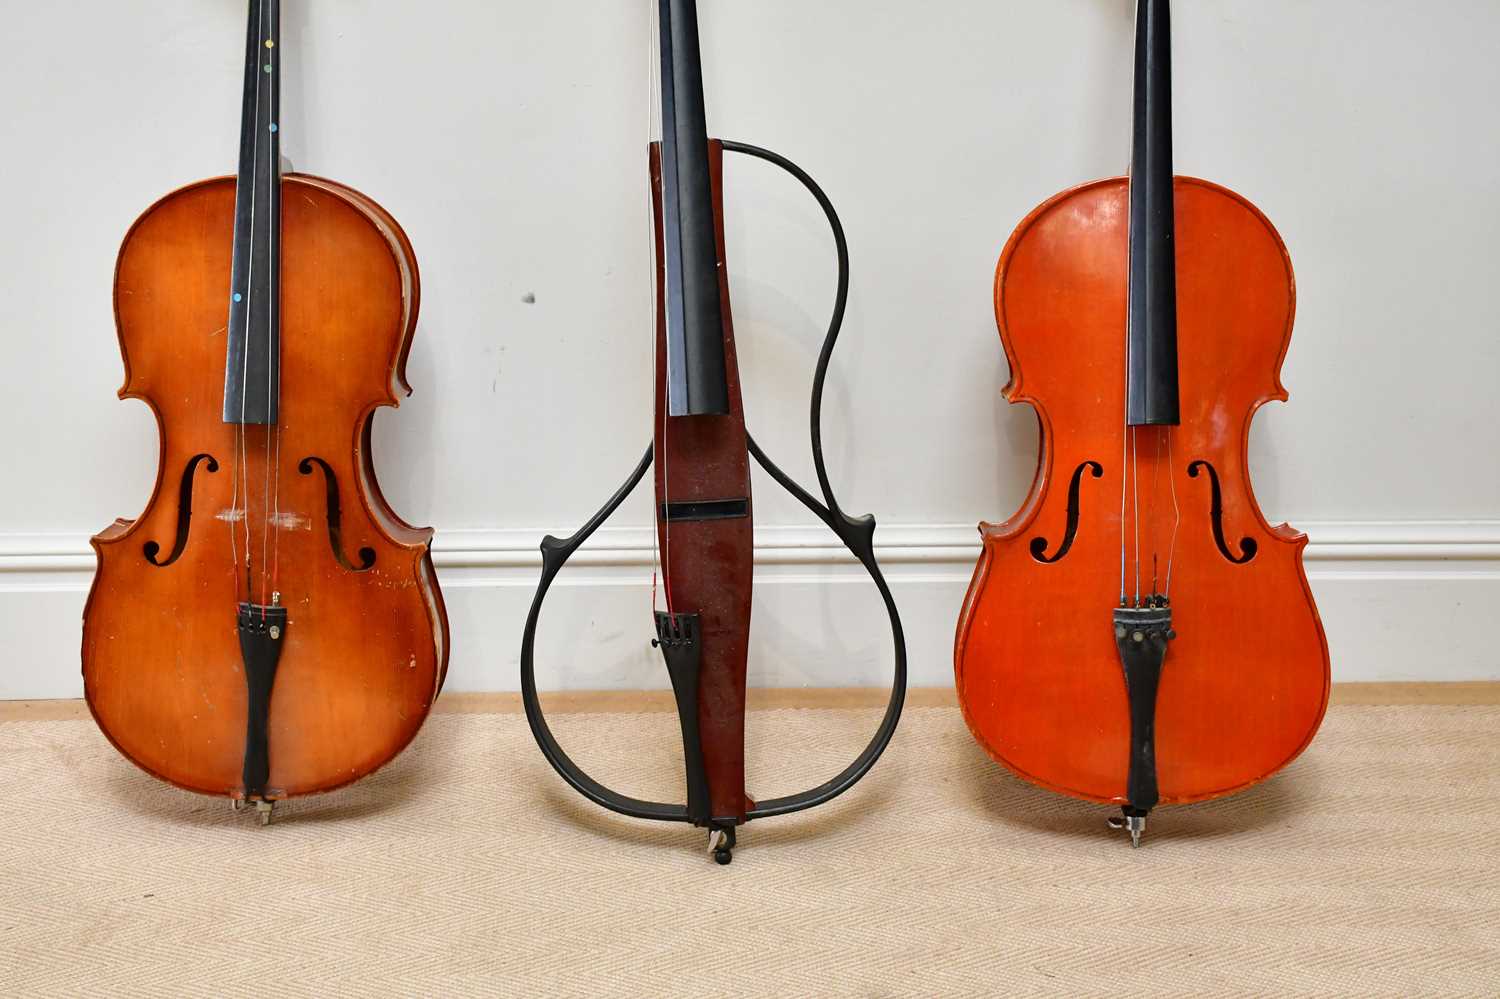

0,0,1500,698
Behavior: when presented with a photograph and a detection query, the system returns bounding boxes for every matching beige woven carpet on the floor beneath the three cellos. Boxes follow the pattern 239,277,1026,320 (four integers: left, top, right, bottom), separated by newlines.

0,696,1500,998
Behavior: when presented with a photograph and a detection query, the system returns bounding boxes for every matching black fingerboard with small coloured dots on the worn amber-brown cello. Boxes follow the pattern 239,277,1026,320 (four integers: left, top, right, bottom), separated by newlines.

224,0,281,425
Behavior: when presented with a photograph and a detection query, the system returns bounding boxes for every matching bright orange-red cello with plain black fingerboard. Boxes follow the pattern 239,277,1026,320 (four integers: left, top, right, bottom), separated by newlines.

954,0,1329,846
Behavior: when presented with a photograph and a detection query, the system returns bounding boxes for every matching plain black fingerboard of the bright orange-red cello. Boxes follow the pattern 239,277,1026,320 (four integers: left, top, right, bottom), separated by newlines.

1125,0,1181,426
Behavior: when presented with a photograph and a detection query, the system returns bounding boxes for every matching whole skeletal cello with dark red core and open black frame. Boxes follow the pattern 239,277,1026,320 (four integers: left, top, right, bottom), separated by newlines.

521,0,906,864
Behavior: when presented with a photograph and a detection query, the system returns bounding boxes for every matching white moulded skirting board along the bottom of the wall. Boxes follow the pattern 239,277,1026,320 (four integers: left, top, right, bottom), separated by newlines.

0,521,1500,699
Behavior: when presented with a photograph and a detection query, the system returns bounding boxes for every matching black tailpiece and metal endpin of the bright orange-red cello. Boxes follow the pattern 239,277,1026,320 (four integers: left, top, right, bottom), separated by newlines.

1115,596,1178,846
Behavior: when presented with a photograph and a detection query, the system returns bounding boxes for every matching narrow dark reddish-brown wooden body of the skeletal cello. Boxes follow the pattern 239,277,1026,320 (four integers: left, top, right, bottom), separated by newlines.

651,141,755,822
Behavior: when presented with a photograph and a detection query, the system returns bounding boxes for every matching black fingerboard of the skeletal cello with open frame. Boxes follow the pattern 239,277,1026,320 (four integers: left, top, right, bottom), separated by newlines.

659,0,729,416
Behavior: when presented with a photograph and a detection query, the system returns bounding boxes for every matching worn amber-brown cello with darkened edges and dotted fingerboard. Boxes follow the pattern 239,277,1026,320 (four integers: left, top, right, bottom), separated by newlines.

83,0,449,824
